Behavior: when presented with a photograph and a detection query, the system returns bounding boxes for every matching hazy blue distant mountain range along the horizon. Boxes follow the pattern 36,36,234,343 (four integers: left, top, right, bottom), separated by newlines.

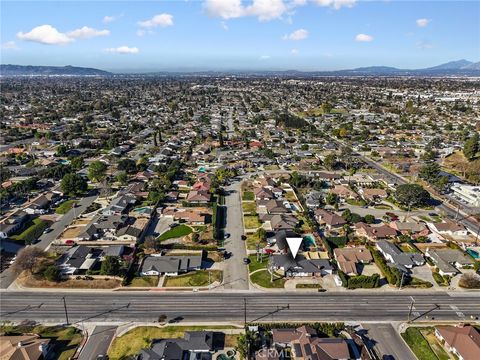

0,59,480,77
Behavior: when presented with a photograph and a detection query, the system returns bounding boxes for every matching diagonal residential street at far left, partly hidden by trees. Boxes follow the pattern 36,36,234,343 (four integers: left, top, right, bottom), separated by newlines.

0,195,98,289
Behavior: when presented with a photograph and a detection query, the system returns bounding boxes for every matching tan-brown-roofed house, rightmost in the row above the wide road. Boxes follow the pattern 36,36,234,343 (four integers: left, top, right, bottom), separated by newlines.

425,248,474,276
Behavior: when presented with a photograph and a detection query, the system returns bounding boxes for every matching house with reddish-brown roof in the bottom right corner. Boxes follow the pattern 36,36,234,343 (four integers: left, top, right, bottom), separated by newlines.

435,325,480,360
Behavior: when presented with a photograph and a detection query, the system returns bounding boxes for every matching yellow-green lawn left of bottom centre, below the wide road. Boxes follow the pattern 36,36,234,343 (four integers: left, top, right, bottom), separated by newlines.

108,324,234,359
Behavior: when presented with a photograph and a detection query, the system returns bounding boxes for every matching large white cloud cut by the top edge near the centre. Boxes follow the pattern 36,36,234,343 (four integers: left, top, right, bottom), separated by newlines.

203,0,286,21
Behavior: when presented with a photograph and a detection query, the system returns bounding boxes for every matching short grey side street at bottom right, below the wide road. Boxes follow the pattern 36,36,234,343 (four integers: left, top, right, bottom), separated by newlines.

362,324,417,360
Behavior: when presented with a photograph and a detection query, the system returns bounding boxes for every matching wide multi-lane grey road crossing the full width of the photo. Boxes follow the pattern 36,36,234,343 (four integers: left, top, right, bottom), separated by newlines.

0,290,480,323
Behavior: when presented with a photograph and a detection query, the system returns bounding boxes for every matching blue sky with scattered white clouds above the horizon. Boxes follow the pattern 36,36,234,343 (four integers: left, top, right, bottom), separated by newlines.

0,0,480,72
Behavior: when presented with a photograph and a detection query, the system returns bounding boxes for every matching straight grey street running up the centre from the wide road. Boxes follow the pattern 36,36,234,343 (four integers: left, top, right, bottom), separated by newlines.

223,181,249,290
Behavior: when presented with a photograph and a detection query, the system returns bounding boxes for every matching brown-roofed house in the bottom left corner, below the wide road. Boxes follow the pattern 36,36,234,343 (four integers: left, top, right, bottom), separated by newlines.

0,334,50,360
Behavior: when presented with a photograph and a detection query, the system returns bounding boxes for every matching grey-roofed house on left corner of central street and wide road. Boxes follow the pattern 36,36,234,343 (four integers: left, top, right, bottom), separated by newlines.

140,255,202,276
